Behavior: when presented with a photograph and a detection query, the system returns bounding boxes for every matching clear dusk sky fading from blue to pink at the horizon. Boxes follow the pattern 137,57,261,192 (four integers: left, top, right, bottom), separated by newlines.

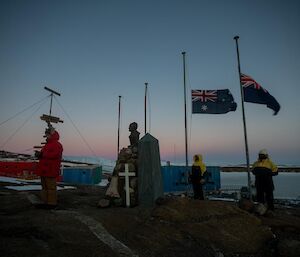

0,0,300,165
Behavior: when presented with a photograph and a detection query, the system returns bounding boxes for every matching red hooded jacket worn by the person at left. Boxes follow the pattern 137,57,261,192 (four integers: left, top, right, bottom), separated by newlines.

37,131,63,177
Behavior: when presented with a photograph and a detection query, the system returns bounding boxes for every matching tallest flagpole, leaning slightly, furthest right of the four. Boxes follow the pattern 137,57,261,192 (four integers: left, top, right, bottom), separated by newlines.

234,36,252,198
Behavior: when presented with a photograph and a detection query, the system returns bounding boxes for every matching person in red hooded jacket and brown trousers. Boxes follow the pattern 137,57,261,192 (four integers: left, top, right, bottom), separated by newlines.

37,127,63,209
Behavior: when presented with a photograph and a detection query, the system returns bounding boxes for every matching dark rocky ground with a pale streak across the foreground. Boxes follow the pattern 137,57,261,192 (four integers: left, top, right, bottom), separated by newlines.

0,182,300,257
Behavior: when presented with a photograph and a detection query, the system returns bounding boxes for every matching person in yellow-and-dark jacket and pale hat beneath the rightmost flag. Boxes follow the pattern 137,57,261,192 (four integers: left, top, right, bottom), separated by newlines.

252,149,278,211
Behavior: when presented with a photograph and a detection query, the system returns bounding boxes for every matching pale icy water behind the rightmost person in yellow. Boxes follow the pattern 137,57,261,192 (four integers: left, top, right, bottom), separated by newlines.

221,172,300,198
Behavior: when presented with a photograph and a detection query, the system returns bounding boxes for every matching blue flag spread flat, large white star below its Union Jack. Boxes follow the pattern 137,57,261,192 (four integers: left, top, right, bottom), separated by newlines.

192,89,237,114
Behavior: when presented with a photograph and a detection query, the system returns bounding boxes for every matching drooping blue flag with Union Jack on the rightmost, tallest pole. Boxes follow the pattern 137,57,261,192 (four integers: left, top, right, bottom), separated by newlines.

241,74,280,115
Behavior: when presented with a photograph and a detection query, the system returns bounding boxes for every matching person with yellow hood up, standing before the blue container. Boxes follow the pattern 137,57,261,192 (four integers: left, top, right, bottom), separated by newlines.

190,154,206,200
